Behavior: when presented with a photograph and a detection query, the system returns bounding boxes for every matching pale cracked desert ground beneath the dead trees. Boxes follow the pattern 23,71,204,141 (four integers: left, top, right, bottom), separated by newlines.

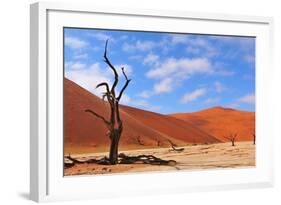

64,141,255,176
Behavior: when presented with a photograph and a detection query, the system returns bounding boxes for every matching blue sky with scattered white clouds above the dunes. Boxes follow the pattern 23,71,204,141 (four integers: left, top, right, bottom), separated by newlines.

64,28,255,114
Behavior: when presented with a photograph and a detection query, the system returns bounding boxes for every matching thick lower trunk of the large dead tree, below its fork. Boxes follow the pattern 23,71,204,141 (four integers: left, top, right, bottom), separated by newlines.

109,129,121,164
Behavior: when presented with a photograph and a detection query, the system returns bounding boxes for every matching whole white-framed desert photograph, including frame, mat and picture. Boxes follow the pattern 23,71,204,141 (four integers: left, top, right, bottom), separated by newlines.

30,3,273,201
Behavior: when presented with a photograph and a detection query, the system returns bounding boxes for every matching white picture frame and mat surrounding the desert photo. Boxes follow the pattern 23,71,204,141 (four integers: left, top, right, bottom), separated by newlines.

30,2,273,202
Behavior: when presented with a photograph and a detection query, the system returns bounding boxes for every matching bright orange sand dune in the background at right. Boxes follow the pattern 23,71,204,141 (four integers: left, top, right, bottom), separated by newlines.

170,107,255,142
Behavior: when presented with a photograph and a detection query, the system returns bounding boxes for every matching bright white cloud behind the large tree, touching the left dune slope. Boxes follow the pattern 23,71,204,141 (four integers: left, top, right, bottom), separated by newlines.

65,63,111,97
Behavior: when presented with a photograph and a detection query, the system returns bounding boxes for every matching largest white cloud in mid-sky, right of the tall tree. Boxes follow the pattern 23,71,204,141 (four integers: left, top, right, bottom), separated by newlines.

146,58,213,79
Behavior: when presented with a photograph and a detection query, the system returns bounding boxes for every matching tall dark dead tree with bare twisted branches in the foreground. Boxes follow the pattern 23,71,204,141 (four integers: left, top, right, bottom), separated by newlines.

85,40,131,164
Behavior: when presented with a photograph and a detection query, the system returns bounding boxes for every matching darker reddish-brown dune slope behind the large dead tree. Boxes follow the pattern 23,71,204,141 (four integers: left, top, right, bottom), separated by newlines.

64,79,220,151
